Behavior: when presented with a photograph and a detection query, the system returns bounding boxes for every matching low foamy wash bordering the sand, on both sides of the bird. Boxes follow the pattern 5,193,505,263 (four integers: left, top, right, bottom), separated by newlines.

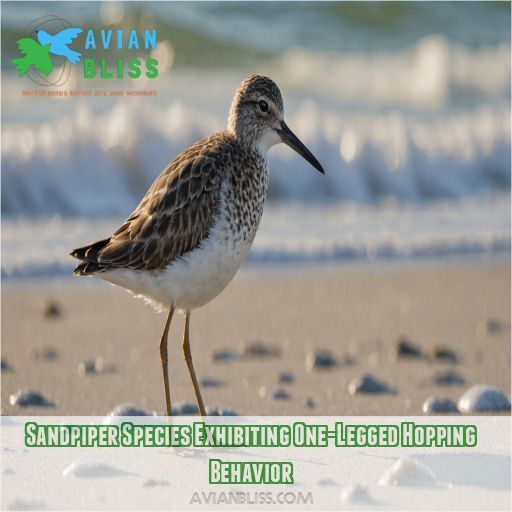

2,194,511,279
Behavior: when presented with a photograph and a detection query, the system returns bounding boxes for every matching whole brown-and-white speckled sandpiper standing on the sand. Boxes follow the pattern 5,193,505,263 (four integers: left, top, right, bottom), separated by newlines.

71,75,324,416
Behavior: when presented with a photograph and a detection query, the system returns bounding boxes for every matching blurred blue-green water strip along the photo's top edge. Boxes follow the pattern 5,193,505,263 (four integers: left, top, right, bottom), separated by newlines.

2,1,510,57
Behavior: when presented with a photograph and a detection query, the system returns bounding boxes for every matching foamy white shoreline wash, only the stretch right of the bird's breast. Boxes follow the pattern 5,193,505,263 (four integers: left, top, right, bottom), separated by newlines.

249,195,511,263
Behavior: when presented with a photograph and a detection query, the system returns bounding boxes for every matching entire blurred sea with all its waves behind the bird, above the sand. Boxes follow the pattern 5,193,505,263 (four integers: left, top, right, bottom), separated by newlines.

1,2,511,280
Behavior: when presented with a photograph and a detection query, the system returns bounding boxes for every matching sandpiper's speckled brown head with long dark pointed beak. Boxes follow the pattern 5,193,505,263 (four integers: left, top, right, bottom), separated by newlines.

228,75,325,174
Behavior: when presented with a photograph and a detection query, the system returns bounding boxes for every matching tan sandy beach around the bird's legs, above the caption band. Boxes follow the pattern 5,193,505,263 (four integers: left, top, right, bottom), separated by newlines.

2,263,510,415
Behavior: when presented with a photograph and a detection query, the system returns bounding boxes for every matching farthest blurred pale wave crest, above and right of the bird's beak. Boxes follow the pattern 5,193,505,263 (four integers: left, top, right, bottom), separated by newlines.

280,35,511,109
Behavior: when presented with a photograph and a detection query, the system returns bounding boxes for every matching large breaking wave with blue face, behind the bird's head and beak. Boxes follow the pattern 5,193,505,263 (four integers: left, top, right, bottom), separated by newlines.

2,84,510,216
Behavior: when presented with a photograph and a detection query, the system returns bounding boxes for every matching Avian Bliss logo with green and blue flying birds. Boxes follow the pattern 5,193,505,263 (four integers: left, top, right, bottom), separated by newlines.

11,15,158,87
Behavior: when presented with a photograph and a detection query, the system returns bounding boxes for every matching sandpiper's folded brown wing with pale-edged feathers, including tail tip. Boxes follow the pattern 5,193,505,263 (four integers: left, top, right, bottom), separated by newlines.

71,134,226,275
